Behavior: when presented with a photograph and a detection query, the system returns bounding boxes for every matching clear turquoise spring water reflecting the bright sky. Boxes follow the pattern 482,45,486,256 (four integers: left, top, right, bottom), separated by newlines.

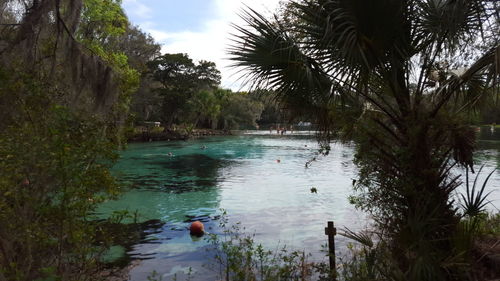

99,128,500,280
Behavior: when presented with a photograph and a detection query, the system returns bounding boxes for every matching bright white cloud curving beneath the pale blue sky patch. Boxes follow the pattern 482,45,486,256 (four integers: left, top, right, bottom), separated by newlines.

125,0,280,90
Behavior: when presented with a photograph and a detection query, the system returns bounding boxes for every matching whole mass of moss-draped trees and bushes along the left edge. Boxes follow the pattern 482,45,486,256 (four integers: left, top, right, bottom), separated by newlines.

0,0,138,280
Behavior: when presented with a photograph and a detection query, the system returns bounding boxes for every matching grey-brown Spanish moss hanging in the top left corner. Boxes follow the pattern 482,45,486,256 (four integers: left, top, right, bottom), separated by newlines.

0,0,118,114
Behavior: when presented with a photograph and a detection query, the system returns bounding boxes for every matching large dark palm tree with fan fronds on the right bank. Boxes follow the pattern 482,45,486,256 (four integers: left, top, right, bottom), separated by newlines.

229,0,500,280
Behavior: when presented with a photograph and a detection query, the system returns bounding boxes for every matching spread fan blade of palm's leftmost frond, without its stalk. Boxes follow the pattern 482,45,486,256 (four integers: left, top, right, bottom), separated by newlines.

229,8,332,105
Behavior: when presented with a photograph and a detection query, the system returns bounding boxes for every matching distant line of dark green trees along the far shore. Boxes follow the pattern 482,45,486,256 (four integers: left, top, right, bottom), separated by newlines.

131,54,308,130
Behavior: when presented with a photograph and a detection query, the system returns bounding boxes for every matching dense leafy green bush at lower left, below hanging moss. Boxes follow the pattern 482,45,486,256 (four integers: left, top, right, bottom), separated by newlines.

0,72,118,280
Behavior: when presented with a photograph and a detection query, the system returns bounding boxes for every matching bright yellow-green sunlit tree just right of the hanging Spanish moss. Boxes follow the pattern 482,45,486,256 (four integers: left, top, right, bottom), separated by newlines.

75,0,141,142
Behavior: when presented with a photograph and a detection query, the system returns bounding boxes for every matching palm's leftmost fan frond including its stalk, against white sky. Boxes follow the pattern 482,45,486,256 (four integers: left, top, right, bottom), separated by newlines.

228,5,363,135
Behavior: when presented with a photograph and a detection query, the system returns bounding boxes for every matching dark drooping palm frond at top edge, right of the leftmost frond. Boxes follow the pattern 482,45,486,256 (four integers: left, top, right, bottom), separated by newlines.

295,0,411,81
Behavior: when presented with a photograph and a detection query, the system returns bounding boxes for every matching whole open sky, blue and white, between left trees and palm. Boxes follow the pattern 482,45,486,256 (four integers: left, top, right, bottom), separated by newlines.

123,0,280,90
